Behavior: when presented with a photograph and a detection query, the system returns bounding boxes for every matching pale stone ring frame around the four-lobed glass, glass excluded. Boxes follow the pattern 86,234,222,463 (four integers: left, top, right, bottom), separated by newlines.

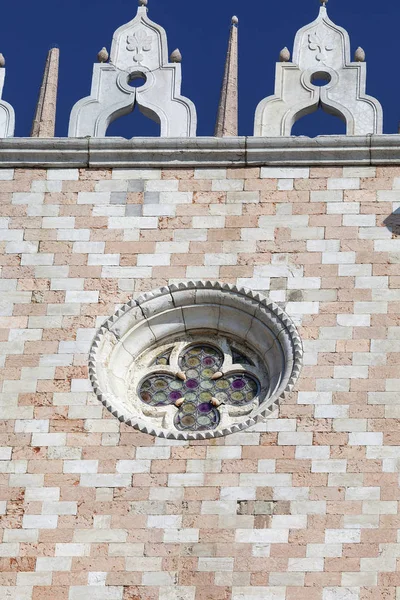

89,281,303,440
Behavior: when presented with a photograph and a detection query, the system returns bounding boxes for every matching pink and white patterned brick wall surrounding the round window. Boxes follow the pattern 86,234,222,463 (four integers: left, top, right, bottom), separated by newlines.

0,167,400,600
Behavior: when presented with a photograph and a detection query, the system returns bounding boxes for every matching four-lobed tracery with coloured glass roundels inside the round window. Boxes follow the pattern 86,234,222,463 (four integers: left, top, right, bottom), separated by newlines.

138,343,261,431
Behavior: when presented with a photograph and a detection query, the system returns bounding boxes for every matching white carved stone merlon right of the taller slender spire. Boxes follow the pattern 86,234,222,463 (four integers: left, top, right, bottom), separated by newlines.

254,6,383,137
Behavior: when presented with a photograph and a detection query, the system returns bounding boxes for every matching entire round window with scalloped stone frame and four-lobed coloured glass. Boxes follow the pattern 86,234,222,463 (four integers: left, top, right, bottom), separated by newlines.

90,282,302,439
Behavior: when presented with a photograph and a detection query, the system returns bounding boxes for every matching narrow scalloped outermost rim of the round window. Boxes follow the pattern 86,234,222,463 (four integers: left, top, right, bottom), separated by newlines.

89,281,303,440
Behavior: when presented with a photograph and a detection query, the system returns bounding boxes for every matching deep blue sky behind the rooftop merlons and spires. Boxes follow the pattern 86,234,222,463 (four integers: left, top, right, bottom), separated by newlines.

0,0,394,138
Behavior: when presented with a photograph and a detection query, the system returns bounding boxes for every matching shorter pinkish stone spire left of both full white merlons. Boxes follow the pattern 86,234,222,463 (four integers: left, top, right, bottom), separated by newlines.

31,48,60,138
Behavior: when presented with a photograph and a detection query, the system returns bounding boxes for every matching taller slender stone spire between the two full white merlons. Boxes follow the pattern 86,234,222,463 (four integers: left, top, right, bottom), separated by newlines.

215,16,239,137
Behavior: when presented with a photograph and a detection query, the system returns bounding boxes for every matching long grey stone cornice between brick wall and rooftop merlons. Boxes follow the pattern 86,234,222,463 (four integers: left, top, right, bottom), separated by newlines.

0,135,400,169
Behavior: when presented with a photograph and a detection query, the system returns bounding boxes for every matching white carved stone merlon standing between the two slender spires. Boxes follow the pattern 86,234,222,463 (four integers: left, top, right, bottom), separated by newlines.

68,5,197,137
